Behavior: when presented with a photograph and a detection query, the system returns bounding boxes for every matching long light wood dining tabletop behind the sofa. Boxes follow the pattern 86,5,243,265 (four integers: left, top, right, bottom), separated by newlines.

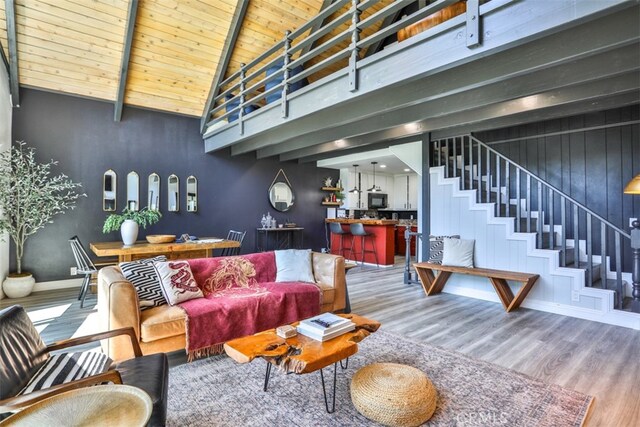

89,237,240,262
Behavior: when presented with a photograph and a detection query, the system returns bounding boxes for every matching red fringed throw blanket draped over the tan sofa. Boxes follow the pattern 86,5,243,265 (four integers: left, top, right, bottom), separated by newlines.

180,252,320,361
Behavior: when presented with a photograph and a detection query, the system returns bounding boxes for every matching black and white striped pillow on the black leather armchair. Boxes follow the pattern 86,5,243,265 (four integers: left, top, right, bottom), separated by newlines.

20,351,112,394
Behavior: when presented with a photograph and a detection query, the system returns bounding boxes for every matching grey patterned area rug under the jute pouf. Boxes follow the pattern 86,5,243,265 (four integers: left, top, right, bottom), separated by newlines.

167,331,593,427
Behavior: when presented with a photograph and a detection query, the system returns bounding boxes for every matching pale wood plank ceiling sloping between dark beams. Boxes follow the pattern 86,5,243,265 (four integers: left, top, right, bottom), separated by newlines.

0,0,391,117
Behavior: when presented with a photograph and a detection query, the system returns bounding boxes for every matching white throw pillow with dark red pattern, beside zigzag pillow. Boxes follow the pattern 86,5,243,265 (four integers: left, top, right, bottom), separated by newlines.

155,261,204,305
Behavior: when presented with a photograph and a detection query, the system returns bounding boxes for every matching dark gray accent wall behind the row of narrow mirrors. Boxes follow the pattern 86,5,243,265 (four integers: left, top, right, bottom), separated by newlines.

11,89,337,282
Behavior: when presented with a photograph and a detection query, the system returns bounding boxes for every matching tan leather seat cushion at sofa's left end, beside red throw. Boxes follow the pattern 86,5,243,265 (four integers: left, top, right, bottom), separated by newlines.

140,304,187,342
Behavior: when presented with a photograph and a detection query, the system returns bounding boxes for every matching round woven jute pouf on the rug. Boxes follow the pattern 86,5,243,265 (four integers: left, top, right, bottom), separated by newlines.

351,363,438,426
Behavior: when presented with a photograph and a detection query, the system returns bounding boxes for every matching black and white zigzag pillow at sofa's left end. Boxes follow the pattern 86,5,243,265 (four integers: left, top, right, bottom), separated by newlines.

119,255,167,310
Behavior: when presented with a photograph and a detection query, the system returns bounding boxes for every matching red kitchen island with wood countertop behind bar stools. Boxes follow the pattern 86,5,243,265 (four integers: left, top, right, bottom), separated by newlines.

325,218,398,265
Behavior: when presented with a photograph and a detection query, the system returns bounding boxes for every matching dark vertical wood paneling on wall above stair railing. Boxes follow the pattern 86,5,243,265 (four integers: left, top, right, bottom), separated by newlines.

477,105,640,271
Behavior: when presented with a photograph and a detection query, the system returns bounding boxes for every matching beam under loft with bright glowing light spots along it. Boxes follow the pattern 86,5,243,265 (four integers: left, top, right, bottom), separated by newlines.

280,73,640,161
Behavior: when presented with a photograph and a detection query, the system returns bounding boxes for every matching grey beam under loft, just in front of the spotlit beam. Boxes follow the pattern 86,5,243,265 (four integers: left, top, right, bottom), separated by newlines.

262,45,640,158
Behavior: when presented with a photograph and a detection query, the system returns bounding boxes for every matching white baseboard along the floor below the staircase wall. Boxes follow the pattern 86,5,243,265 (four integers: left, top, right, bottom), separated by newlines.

442,285,640,330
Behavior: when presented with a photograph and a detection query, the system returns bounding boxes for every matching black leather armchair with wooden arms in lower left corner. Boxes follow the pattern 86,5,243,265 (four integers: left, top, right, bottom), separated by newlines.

0,305,169,426
